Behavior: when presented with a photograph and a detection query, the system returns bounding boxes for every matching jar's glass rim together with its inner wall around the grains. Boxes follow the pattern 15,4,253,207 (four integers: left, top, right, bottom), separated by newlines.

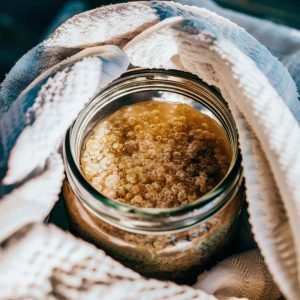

64,69,242,217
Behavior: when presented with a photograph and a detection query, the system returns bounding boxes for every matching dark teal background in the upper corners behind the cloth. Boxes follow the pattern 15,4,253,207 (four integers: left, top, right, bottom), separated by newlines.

0,0,300,82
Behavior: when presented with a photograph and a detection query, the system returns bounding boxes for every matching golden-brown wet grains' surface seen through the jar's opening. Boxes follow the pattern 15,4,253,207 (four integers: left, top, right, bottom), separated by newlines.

80,101,231,208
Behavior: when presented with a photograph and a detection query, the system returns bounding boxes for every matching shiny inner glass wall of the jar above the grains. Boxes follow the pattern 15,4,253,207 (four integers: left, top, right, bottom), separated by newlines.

71,73,237,169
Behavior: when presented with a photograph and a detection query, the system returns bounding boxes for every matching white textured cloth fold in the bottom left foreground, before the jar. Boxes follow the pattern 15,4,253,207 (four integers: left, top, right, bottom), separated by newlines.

0,225,216,300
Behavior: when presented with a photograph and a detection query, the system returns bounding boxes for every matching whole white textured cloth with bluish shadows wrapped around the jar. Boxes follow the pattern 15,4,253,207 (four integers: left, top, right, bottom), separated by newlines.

0,1,300,299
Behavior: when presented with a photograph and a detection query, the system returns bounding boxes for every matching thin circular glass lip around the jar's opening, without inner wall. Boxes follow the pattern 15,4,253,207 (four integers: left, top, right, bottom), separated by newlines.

63,69,242,227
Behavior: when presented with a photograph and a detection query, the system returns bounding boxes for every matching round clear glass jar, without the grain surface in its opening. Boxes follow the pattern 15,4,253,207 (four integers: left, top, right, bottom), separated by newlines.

63,69,244,281
